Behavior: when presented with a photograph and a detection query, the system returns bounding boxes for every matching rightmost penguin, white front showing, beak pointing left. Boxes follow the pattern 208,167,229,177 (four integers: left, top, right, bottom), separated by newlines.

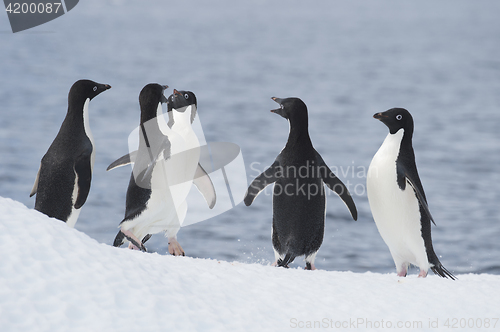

367,108,455,279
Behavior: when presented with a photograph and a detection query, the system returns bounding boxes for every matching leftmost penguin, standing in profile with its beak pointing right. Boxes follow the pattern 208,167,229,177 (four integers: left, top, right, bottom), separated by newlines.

30,80,111,227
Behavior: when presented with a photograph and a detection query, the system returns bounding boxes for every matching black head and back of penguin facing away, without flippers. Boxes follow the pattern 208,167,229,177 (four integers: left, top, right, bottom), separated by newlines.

273,98,326,262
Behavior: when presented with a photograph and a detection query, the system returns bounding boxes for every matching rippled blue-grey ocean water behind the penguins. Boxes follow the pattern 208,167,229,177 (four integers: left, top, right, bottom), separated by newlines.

0,0,500,274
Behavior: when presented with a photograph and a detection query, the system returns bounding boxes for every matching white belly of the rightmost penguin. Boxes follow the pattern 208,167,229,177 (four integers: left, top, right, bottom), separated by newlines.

367,130,429,268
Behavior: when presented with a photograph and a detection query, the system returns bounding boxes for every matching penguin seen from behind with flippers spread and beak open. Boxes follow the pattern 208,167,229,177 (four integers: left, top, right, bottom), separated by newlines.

244,97,357,270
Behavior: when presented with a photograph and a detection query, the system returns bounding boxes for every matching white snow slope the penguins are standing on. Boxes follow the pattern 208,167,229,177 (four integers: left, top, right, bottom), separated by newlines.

0,197,500,331
